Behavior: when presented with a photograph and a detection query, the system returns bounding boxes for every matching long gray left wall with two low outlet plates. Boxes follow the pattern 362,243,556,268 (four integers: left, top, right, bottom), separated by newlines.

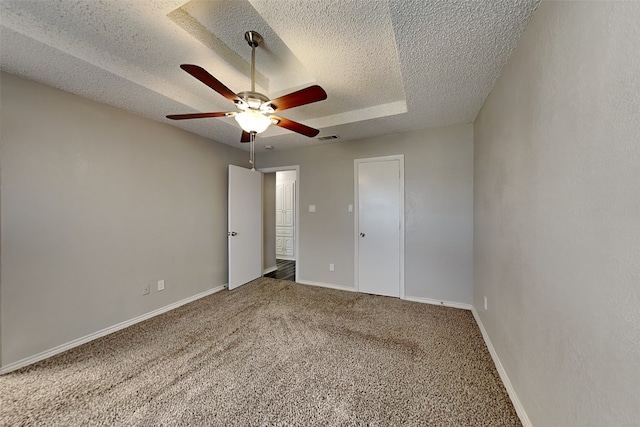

0,73,246,366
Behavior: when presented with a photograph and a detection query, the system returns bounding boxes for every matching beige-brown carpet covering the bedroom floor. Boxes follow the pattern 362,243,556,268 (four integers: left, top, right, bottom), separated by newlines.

0,278,521,427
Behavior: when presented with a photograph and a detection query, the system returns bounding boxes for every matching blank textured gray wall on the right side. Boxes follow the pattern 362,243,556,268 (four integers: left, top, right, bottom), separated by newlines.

474,2,640,427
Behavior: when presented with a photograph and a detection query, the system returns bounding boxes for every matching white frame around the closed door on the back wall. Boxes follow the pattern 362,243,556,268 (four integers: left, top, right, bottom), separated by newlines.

356,154,405,299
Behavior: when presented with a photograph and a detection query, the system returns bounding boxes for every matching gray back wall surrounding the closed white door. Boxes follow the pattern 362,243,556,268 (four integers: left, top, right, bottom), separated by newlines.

257,125,473,304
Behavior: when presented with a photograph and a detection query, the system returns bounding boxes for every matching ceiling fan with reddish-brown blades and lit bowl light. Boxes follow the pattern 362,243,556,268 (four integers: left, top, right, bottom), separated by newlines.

167,31,327,145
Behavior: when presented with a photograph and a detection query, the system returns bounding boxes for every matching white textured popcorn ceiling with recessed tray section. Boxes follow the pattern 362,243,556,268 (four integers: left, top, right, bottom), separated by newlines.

0,0,539,151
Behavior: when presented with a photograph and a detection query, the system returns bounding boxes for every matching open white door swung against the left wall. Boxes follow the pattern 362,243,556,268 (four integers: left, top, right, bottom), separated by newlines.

228,165,262,290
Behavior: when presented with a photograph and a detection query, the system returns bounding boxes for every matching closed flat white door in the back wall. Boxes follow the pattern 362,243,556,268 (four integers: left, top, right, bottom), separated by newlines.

355,156,404,298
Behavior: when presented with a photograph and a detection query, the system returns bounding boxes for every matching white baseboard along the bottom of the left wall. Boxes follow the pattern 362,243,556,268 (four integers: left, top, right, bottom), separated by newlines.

0,284,227,375
